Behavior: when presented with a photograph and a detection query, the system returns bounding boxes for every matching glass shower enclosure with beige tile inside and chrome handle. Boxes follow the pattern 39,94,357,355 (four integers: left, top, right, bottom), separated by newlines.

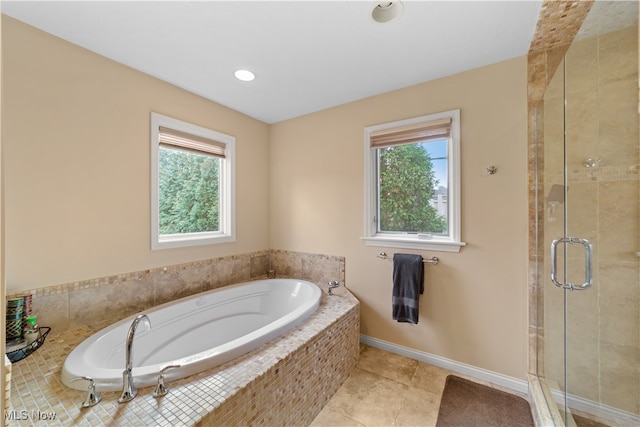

537,1,640,426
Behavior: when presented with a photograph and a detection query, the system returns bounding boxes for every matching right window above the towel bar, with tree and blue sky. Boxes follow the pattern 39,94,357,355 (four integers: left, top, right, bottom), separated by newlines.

364,110,465,252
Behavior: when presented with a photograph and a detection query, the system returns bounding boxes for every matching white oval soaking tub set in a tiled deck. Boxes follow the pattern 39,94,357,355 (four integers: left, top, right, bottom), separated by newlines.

62,279,322,391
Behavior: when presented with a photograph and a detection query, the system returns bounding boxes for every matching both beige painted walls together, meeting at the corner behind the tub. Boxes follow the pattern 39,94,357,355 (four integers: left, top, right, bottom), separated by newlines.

2,17,527,379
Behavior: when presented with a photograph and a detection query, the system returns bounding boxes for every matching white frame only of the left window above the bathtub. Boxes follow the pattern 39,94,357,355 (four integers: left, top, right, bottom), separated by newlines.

151,113,236,250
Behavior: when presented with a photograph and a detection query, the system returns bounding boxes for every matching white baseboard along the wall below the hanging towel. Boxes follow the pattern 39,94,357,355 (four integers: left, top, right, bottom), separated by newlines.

360,335,529,395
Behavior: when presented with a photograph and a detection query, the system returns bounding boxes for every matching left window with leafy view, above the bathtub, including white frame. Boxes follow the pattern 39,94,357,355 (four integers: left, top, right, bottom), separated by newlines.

151,113,235,249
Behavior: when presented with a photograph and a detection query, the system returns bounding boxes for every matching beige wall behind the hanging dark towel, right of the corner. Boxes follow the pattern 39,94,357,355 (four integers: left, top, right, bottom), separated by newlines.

270,57,527,379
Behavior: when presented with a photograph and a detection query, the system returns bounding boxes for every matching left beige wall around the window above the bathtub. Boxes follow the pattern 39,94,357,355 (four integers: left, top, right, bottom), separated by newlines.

2,16,269,293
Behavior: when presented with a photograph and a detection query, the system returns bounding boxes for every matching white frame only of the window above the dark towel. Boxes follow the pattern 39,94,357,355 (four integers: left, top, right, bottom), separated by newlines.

362,109,465,252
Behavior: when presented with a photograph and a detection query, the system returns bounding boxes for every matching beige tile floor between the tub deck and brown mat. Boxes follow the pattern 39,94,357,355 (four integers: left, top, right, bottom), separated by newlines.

311,345,451,427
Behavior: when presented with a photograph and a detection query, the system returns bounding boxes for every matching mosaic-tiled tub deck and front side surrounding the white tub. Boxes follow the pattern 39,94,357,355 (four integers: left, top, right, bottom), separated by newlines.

8,288,360,426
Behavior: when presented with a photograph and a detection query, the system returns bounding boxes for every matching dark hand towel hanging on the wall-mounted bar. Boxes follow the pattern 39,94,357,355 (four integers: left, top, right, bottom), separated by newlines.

391,254,424,324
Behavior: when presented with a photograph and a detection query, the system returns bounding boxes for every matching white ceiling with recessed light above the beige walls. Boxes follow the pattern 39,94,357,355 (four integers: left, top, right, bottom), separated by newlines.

1,0,542,123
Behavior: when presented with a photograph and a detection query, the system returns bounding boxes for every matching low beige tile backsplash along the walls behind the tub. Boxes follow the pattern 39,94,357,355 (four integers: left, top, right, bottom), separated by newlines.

7,250,345,338
